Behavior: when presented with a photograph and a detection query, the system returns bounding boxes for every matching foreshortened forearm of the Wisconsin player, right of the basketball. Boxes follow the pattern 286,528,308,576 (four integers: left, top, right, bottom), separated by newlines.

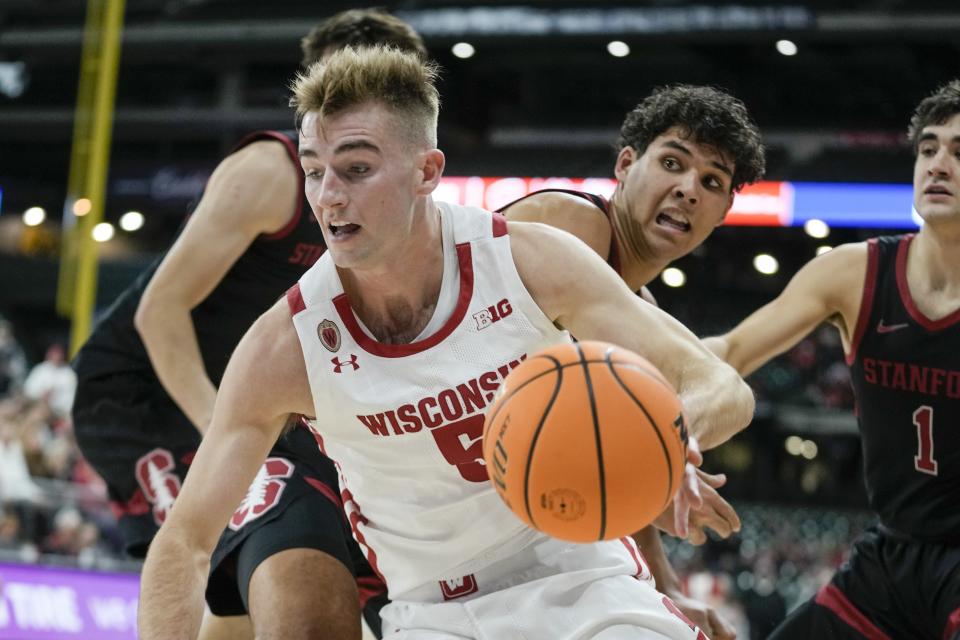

679,361,754,449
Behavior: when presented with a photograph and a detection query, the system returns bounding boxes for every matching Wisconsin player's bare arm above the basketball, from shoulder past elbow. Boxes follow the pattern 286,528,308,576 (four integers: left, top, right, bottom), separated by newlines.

509,223,753,447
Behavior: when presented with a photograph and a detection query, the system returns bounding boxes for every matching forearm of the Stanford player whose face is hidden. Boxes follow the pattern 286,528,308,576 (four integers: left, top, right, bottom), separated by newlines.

136,300,217,433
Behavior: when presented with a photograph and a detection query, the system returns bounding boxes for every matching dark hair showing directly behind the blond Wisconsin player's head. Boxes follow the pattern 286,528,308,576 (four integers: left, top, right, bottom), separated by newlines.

300,9,427,68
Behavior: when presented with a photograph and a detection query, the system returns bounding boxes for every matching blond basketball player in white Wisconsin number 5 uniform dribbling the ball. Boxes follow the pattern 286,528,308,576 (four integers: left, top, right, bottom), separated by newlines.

139,48,753,640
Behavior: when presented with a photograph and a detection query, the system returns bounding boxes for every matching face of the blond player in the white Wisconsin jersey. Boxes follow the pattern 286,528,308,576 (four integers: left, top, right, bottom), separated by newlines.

300,103,418,269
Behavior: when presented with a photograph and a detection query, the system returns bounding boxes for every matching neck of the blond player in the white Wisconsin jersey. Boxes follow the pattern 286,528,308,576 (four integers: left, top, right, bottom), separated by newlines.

340,204,443,344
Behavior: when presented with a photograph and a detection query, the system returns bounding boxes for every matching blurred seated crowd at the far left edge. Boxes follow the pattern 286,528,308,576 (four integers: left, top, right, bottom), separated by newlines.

0,319,122,566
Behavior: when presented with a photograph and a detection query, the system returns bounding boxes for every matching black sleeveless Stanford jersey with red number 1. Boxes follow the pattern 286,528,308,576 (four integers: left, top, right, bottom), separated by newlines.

848,235,960,544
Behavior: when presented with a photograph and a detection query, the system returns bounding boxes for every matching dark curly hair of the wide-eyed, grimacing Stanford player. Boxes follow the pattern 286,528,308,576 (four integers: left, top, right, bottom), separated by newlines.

617,84,766,191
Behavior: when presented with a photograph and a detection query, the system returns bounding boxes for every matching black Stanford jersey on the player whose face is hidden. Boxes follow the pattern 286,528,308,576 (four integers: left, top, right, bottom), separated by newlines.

75,131,326,386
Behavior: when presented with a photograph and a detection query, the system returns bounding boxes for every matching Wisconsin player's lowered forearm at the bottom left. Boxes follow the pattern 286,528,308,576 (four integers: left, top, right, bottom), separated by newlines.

137,527,210,640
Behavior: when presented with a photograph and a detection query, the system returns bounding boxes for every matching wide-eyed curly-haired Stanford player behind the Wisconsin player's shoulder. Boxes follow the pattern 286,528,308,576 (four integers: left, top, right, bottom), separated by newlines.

500,85,765,640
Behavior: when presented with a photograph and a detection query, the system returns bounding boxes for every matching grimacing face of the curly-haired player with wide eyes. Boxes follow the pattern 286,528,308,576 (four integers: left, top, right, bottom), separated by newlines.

615,127,734,262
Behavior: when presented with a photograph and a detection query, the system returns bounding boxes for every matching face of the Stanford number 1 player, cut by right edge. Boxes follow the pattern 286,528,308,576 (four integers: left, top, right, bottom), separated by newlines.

913,113,960,223
